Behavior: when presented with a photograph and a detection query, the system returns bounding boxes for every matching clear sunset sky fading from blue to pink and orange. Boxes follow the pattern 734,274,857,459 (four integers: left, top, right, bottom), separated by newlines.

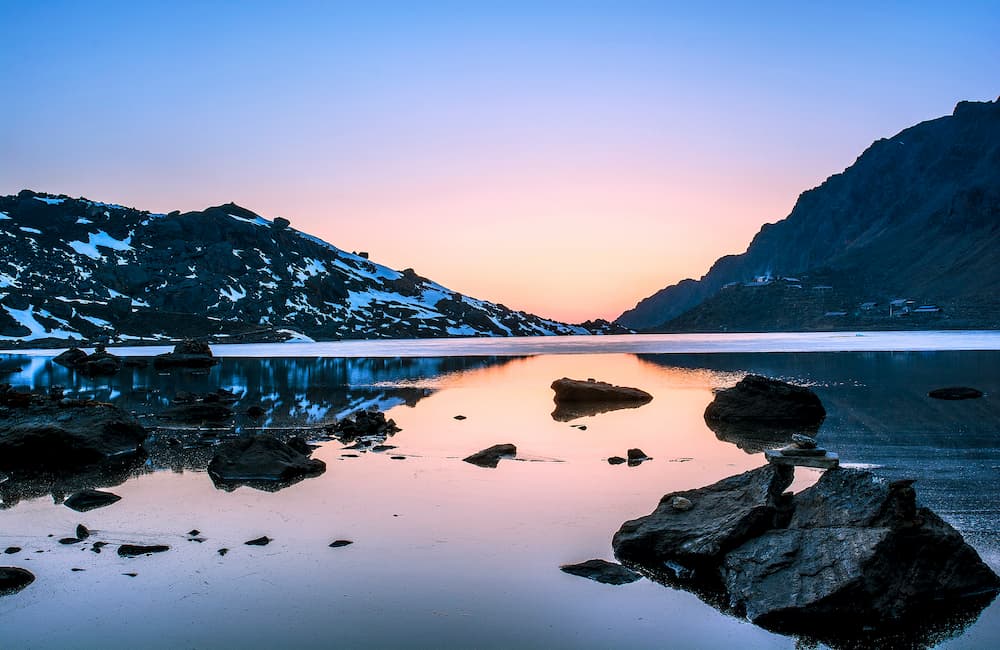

0,0,1000,322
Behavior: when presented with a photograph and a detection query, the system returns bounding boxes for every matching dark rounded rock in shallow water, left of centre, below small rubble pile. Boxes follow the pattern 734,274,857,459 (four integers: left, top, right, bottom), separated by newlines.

208,435,326,489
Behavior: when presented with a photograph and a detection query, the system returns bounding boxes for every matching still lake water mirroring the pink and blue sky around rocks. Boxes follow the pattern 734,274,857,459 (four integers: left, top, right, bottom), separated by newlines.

0,333,1000,648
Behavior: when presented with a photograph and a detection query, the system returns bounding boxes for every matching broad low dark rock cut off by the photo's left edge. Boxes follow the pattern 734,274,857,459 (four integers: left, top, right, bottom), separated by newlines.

0,394,146,470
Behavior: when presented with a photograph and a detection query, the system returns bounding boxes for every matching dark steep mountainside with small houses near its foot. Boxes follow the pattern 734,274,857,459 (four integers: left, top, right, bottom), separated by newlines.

618,100,1000,331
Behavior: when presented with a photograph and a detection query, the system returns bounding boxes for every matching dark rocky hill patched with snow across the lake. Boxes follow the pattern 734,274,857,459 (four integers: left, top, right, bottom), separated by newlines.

0,190,616,345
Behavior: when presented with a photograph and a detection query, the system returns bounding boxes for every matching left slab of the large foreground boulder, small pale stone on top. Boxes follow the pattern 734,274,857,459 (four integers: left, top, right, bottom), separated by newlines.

612,465,793,570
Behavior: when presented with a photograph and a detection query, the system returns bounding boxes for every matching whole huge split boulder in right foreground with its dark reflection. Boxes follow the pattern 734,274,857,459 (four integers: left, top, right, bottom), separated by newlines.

615,466,1000,639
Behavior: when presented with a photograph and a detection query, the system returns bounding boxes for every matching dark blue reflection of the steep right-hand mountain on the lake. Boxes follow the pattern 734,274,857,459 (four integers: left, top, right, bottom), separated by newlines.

638,351,1000,549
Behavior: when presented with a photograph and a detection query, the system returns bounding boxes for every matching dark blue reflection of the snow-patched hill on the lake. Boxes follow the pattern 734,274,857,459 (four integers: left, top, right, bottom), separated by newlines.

0,355,514,498
